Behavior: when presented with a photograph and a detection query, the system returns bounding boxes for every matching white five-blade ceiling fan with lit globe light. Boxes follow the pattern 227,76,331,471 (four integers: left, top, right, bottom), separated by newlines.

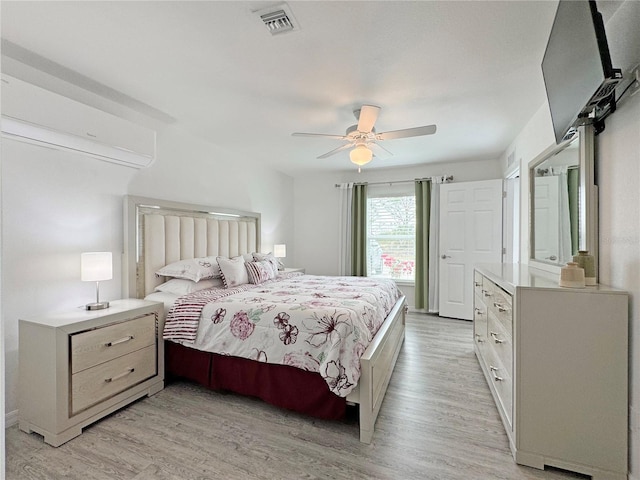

291,105,436,171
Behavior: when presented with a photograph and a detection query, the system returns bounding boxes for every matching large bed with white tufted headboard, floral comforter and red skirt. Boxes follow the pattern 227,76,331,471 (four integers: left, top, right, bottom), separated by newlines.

124,196,406,443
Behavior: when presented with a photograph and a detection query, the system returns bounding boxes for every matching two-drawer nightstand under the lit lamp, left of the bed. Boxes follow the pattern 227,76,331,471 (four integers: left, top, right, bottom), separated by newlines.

19,299,164,447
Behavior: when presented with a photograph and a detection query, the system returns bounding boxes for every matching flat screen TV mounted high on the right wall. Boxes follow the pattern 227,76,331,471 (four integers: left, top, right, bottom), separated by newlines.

542,0,622,143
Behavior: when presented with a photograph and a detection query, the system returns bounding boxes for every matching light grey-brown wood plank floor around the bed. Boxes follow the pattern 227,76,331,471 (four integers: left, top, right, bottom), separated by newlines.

6,314,584,480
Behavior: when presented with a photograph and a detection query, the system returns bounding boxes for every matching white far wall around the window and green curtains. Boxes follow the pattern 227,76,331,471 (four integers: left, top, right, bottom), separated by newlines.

287,160,502,306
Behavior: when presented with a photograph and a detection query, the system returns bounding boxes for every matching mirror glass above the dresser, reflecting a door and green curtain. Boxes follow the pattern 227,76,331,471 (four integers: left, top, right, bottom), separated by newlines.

531,135,580,265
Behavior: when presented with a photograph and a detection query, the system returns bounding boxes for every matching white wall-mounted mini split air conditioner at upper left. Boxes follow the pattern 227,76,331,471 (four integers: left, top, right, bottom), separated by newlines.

0,75,156,168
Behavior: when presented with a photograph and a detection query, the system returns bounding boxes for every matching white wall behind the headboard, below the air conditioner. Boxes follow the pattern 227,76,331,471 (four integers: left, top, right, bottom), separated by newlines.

1,126,295,422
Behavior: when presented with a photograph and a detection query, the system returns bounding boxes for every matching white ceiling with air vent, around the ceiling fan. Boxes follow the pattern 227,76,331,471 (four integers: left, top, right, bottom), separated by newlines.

1,1,556,175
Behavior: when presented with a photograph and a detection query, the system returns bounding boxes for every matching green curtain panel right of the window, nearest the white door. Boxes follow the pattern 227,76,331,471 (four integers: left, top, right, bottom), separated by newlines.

415,180,431,309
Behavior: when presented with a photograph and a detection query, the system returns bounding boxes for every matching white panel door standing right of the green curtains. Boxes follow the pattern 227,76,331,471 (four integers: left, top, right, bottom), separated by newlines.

439,179,502,320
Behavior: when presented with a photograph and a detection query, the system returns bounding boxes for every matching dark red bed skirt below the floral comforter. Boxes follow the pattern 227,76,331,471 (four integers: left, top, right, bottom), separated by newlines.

165,341,347,420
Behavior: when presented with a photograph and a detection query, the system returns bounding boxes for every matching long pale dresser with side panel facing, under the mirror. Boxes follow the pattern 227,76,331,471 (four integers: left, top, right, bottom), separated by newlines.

474,264,629,480
